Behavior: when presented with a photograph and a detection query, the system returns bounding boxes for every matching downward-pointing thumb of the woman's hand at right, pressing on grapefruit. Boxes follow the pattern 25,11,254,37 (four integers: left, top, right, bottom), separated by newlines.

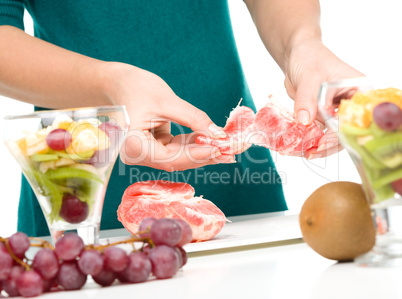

294,80,320,125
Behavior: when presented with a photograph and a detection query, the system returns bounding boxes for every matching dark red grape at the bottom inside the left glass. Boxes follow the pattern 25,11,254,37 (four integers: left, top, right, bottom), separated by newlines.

60,194,89,223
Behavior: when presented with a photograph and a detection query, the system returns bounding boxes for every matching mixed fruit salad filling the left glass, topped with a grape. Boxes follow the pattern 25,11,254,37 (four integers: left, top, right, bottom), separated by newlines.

7,114,121,229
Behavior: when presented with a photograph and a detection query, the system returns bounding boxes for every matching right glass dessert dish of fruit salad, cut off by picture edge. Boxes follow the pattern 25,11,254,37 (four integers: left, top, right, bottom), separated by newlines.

318,78,402,267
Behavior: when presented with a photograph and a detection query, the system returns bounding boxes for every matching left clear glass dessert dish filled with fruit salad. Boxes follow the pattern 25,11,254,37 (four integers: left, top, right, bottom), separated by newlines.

4,106,129,244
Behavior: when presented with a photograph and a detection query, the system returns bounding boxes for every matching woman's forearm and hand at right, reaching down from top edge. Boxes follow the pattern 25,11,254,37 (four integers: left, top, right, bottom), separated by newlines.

244,0,363,159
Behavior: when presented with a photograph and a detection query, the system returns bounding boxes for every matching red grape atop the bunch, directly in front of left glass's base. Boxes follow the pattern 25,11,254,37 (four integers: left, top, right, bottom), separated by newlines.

54,233,84,261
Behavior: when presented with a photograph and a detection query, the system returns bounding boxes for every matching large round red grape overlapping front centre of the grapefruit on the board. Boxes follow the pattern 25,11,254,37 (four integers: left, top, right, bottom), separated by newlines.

151,218,182,246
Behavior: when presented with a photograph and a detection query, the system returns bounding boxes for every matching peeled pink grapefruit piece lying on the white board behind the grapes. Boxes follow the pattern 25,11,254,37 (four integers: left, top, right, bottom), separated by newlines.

117,180,227,241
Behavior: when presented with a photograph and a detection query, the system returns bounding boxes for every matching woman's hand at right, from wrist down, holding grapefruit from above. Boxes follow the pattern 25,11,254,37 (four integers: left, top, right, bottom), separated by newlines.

285,39,363,159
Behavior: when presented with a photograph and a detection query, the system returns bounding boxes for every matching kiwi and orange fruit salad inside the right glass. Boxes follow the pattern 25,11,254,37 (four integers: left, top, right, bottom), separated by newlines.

338,88,402,203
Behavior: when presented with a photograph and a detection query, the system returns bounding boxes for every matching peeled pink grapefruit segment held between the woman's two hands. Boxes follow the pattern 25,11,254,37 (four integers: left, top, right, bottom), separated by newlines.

195,98,324,155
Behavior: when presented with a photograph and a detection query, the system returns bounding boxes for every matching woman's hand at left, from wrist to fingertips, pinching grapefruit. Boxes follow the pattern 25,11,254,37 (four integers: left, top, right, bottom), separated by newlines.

105,63,235,171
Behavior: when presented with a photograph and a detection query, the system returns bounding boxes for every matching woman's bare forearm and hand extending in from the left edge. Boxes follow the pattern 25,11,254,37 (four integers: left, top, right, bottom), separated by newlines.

0,26,228,171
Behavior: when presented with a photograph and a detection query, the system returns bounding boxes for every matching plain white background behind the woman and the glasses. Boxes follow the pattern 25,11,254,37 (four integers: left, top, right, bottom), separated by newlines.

0,0,402,237
